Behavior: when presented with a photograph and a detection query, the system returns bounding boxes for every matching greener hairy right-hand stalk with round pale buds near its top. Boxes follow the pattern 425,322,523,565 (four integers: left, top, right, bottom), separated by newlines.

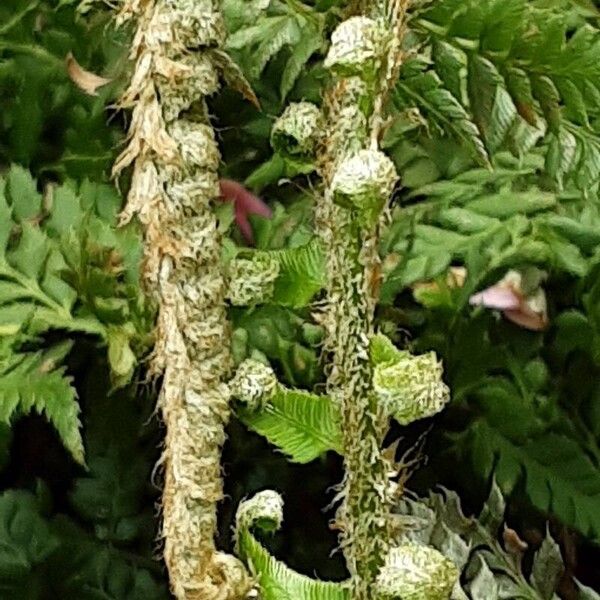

317,1,405,600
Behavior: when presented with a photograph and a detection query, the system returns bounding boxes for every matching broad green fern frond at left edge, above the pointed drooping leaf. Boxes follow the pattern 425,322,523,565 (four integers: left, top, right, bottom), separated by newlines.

0,166,150,383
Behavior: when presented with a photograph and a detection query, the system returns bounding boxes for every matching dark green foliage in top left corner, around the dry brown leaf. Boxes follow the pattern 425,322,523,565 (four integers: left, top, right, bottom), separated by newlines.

0,0,125,178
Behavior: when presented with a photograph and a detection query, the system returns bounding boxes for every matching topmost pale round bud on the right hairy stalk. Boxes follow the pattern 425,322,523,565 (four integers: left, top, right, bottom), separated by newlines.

325,16,389,79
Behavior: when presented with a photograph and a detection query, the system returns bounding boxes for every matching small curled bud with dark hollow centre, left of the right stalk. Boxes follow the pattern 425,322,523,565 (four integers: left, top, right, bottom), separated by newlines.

271,102,322,157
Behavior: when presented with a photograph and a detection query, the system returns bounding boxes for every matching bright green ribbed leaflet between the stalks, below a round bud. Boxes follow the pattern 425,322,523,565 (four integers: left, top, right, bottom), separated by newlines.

238,386,342,463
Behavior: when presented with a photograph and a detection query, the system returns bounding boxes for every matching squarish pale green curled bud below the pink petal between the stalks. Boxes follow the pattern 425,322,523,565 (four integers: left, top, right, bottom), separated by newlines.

227,253,279,306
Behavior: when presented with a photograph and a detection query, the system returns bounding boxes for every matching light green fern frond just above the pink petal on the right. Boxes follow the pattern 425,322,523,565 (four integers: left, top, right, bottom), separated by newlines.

382,153,600,302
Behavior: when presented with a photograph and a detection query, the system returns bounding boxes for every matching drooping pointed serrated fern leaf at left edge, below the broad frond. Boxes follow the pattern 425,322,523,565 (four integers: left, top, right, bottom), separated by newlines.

0,342,84,464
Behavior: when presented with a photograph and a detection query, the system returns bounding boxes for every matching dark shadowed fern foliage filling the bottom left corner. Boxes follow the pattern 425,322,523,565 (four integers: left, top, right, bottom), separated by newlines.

0,364,169,600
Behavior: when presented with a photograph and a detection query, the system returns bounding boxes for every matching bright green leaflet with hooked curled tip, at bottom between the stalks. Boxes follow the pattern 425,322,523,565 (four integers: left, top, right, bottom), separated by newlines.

236,490,349,600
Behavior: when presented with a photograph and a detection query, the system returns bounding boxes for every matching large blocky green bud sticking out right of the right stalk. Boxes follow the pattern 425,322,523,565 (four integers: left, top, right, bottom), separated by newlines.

373,352,450,425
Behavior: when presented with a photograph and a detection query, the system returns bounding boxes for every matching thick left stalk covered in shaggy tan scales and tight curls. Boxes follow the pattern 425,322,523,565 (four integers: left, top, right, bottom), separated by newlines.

114,0,250,600
